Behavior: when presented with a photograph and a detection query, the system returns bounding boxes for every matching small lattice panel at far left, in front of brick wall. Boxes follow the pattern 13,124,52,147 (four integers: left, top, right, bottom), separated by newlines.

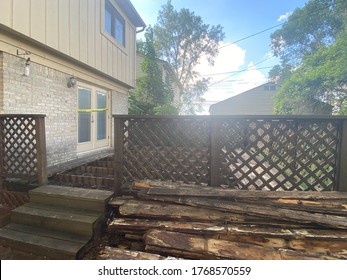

1,116,38,178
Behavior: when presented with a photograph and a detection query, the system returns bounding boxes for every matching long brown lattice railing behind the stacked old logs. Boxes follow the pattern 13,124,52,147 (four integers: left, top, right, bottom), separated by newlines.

114,115,347,193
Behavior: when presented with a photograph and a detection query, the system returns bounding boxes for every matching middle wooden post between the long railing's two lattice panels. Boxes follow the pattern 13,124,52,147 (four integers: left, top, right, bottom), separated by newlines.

210,117,221,187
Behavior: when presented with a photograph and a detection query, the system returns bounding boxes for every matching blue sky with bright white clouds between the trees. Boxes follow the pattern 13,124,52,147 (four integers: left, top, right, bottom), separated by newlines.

131,0,308,112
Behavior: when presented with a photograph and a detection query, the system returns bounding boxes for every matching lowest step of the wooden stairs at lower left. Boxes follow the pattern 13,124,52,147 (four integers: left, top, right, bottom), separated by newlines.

0,223,89,259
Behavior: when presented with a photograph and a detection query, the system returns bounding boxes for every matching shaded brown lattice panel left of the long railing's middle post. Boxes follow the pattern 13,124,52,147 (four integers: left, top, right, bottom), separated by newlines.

123,118,210,184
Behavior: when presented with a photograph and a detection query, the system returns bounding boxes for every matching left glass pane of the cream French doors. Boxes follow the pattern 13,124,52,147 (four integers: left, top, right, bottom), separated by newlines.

78,88,91,143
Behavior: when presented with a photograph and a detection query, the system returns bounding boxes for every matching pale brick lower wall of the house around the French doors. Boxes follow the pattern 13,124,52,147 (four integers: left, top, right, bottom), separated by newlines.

0,52,127,170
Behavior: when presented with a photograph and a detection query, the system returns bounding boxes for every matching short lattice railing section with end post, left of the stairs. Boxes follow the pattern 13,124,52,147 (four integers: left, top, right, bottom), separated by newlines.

0,115,47,189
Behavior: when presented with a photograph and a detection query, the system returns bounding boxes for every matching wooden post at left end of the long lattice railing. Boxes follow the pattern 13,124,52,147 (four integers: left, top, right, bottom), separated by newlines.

114,117,123,196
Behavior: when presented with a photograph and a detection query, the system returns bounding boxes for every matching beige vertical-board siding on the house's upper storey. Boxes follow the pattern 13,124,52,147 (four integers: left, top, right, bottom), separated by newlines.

0,0,136,87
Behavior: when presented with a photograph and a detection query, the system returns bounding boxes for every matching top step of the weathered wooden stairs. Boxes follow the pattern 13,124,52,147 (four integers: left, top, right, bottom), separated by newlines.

29,185,113,213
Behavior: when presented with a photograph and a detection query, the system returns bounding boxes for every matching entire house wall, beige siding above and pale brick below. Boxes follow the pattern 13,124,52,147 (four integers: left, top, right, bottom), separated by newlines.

0,0,141,170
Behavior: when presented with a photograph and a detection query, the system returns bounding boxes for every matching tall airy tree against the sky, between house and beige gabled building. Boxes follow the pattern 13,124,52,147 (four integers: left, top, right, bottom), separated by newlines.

153,0,224,113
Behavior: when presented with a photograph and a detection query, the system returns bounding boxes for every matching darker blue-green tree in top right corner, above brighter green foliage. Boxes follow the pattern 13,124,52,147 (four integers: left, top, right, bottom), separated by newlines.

269,0,347,81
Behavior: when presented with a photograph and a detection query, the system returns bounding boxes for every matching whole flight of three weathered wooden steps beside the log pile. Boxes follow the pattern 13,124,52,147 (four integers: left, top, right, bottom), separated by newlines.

0,185,113,259
